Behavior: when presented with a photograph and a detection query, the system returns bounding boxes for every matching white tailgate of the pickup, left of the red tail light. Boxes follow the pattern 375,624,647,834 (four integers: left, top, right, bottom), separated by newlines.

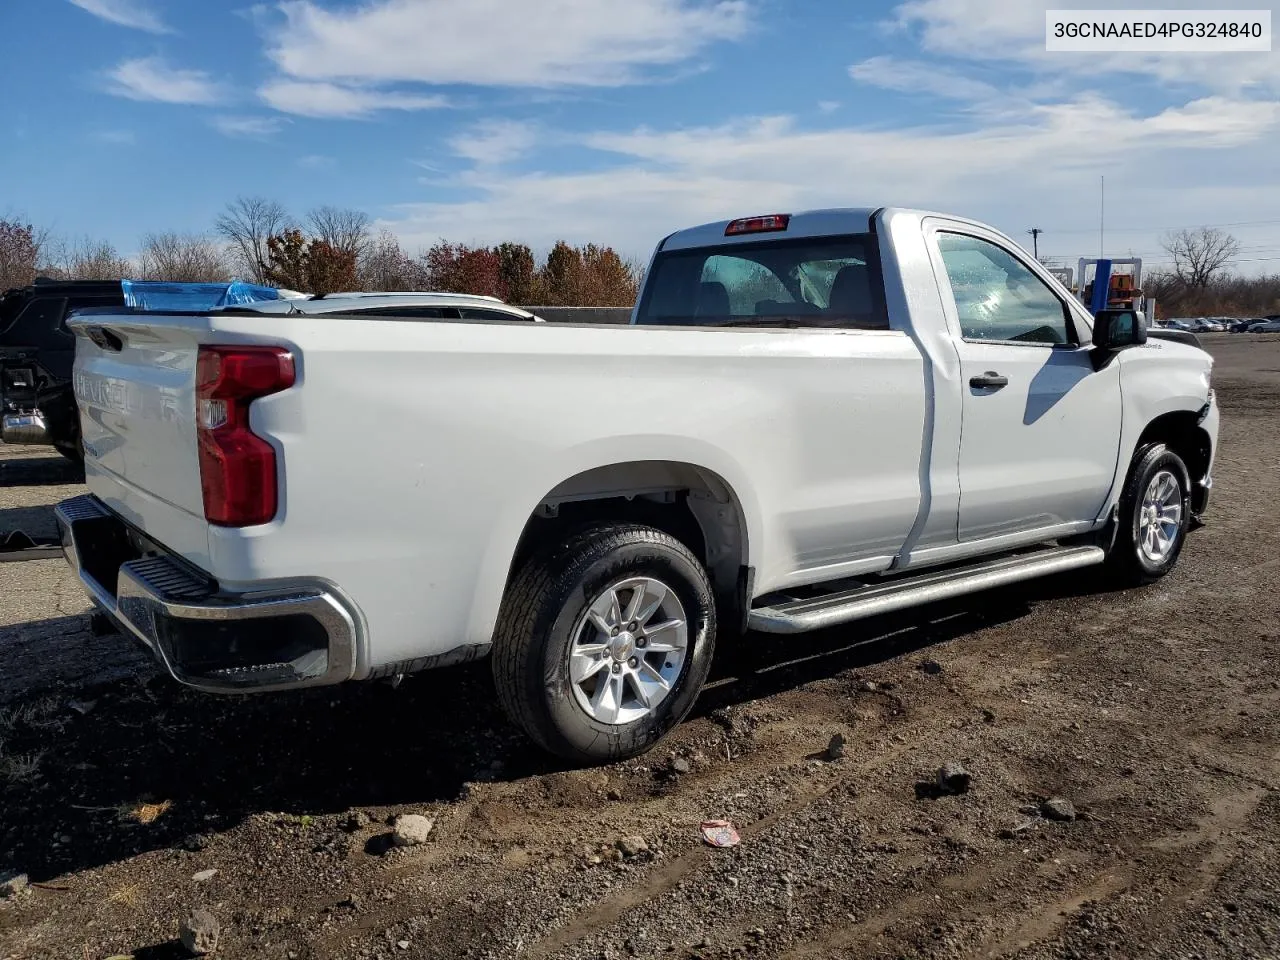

69,314,210,568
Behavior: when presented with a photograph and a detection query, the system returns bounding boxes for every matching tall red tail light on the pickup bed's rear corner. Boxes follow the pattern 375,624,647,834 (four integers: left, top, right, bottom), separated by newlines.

196,347,294,526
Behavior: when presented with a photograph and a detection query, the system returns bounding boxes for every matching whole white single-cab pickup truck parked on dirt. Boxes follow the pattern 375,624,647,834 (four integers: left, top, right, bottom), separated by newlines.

58,209,1219,762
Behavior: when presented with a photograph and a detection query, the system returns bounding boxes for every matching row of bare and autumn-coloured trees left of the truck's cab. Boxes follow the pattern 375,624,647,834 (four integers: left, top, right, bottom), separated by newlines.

0,197,643,307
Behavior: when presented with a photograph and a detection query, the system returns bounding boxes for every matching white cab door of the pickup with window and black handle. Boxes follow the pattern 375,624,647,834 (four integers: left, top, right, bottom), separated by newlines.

932,224,1120,543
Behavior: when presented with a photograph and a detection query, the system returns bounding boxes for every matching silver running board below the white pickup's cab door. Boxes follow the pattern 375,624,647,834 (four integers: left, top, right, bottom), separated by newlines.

748,547,1106,634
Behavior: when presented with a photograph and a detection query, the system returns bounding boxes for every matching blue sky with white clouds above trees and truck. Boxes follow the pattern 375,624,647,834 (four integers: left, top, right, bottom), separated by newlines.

0,0,1280,273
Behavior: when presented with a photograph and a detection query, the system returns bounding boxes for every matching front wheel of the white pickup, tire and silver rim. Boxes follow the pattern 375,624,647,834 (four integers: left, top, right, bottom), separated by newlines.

1107,443,1192,586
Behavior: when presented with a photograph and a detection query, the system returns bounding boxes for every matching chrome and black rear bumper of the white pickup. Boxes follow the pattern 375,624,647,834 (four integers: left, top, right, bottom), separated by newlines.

55,497,356,694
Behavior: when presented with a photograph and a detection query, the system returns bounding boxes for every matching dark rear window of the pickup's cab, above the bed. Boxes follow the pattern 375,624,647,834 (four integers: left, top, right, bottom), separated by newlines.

636,234,888,330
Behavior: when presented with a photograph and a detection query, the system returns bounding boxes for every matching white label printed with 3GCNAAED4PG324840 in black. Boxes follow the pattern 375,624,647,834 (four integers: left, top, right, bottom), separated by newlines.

1044,10,1271,54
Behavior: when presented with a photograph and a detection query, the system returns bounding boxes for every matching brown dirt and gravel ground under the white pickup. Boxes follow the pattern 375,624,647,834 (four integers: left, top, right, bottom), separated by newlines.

0,334,1280,960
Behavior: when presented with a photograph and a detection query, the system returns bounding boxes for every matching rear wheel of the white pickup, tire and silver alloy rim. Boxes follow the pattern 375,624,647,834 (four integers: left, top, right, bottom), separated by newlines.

492,524,716,763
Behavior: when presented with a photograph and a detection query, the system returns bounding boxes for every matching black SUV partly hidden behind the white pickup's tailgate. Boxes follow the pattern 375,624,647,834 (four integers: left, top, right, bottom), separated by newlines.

0,278,124,462
